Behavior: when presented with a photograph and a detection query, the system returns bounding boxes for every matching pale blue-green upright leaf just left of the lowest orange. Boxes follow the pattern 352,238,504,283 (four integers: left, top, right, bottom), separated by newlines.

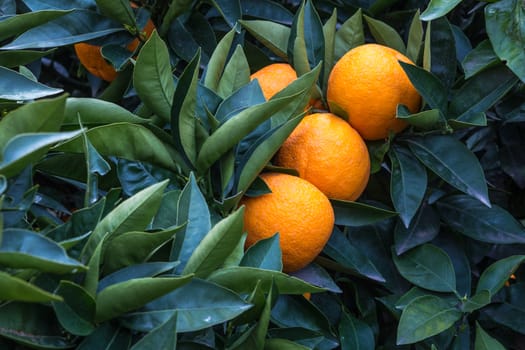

170,173,212,273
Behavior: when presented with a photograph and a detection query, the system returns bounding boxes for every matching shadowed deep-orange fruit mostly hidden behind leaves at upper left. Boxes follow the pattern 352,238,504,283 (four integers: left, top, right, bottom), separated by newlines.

74,3,155,81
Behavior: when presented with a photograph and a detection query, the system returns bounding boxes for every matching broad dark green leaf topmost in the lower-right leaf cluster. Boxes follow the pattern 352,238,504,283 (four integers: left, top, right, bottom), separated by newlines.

393,244,456,292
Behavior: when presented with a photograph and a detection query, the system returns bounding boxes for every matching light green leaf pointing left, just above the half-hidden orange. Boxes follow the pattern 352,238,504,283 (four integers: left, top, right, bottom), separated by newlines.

239,20,290,60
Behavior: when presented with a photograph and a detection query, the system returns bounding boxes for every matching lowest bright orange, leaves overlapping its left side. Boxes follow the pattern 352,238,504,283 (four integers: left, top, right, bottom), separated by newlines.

241,172,334,272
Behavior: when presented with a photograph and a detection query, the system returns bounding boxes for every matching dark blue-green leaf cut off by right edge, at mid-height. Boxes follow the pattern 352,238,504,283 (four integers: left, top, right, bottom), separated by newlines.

437,195,525,244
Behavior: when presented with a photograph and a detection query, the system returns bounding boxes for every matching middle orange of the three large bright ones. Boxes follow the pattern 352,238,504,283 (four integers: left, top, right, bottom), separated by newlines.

274,113,370,201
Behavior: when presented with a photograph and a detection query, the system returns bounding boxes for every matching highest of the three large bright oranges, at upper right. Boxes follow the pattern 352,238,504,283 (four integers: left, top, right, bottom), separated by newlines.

327,44,421,140
